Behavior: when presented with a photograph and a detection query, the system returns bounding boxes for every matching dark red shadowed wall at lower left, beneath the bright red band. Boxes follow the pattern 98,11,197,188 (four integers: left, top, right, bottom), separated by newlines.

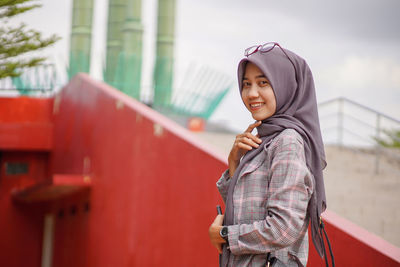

0,151,48,267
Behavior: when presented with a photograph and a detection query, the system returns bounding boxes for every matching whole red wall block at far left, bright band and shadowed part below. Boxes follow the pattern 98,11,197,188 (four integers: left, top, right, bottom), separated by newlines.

0,97,52,267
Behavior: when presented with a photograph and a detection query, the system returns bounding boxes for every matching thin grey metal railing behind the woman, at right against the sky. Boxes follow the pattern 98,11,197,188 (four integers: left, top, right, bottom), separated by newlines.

318,97,400,173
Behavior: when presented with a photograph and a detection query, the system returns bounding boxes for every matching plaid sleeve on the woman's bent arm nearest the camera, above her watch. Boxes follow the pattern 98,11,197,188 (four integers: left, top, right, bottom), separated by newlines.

228,140,313,255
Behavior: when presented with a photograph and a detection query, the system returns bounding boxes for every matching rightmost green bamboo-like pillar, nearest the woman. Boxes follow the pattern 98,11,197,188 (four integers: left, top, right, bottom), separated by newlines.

153,0,175,108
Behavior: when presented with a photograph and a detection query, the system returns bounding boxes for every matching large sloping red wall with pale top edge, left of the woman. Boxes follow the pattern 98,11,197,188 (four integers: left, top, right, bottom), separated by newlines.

52,75,226,266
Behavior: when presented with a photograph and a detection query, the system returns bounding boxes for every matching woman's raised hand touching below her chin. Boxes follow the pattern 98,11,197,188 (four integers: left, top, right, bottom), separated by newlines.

228,121,262,177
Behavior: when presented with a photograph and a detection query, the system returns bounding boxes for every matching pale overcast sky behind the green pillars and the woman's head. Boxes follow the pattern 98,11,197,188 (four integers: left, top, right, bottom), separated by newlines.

10,0,400,134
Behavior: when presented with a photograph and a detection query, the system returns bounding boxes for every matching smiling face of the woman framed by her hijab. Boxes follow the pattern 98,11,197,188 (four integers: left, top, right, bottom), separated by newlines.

242,62,276,121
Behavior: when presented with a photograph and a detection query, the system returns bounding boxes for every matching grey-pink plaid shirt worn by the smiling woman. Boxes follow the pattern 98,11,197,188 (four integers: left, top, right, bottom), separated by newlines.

217,129,314,266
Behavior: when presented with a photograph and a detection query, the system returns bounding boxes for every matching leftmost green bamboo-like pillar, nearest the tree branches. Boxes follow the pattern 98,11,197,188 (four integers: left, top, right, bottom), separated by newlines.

68,0,93,79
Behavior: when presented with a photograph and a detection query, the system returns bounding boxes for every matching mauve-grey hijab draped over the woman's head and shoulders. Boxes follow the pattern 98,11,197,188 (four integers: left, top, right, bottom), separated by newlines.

221,46,326,266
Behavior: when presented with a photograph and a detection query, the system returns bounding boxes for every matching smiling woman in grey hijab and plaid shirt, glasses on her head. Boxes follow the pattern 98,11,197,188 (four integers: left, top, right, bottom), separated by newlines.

209,43,326,266
